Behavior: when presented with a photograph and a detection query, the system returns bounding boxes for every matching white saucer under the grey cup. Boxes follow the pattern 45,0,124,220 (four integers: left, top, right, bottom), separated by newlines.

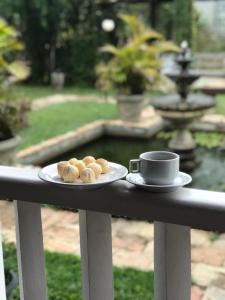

126,172,192,193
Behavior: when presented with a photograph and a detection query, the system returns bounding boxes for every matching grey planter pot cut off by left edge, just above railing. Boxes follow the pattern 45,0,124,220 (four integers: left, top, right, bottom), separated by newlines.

0,136,21,165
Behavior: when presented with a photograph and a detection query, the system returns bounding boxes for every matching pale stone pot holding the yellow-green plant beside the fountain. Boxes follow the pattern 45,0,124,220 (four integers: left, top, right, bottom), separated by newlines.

117,95,146,122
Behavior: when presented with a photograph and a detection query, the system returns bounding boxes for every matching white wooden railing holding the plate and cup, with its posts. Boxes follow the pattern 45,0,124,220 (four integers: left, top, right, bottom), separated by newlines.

0,167,225,300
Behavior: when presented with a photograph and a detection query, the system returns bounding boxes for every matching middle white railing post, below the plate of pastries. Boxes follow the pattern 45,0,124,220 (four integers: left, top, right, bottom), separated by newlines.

79,210,114,300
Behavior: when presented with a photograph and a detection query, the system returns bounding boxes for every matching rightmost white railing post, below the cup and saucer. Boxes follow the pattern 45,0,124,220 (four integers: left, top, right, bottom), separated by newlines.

154,222,191,300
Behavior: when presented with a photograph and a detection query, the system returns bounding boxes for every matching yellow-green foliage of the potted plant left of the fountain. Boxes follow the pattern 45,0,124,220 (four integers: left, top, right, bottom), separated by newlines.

96,15,180,92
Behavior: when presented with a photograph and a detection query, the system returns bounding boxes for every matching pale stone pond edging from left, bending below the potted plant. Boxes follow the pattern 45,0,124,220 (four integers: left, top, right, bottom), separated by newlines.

17,107,163,165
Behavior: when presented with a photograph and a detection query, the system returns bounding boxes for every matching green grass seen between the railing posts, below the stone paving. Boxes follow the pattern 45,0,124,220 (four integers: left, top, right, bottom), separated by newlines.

4,244,153,300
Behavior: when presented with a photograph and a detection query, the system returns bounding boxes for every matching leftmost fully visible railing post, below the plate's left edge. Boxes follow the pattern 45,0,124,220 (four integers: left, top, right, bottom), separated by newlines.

14,201,47,300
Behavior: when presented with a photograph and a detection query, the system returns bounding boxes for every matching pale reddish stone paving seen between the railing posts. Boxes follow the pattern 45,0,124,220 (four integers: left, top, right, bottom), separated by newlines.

0,201,225,300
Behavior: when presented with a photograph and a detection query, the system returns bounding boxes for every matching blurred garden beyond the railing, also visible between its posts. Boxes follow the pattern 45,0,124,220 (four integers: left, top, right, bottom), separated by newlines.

0,0,225,300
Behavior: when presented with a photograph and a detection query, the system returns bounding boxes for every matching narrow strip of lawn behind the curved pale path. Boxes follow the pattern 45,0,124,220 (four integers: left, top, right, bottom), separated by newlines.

14,85,112,100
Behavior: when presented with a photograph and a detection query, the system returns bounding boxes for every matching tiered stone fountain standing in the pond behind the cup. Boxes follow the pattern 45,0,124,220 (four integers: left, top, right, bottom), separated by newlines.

153,41,215,170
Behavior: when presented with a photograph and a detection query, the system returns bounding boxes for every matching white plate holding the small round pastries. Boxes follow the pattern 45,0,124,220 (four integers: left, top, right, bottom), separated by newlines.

38,162,128,189
